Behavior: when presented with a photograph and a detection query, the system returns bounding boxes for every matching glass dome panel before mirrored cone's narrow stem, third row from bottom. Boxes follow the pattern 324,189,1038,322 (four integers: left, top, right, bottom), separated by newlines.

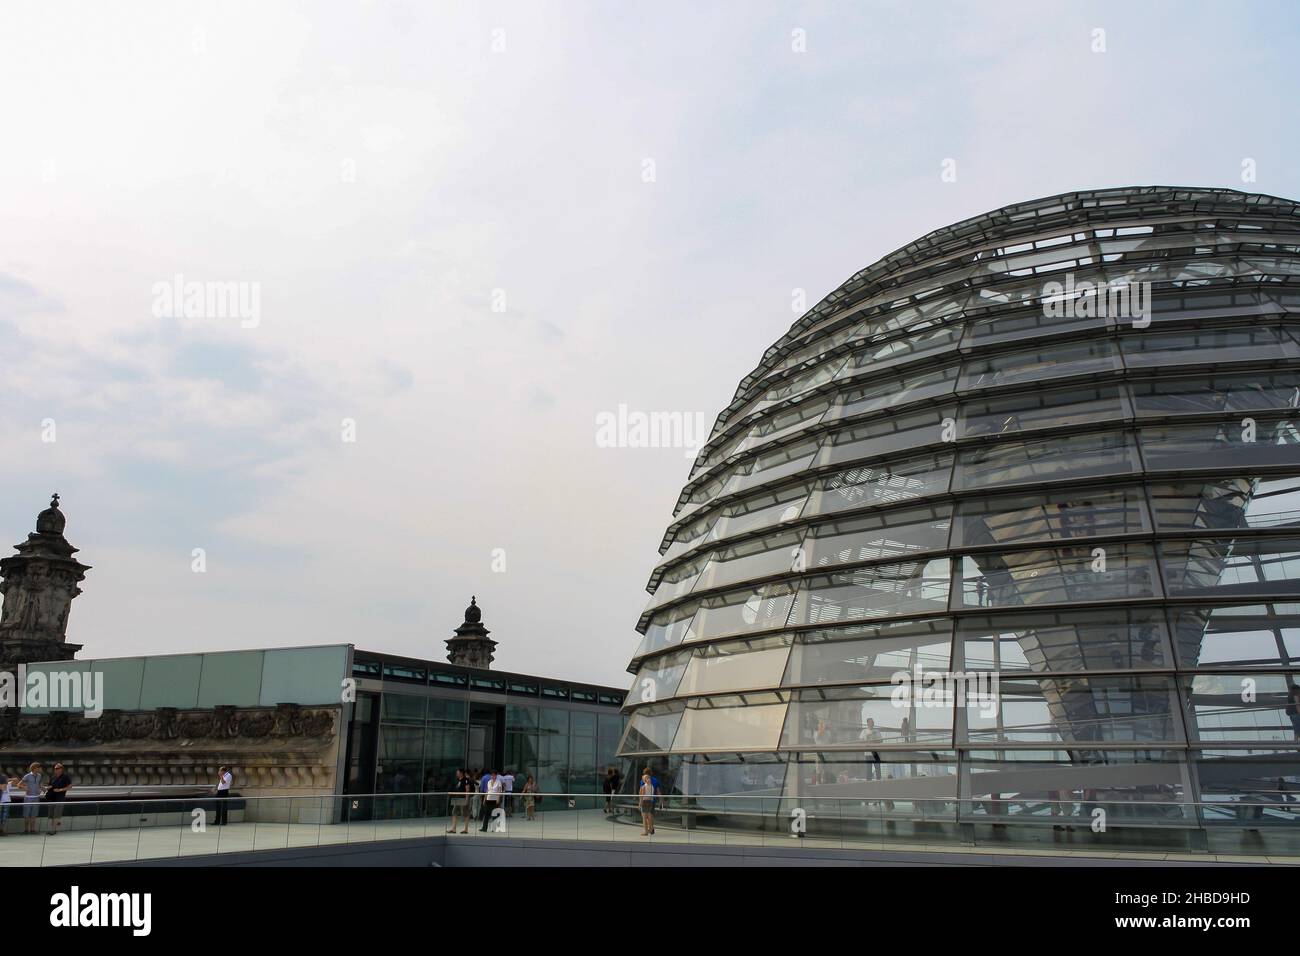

957,607,1173,674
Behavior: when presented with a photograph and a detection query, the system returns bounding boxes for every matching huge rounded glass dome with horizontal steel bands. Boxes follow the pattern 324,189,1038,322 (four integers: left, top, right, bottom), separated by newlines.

620,187,1300,832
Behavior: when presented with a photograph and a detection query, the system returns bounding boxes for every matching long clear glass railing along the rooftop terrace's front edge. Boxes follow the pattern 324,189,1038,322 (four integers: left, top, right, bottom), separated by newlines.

0,792,1300,866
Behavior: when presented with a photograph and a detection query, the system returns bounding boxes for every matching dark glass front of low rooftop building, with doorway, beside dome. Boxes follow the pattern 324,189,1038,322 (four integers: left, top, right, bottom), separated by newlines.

343,650,625,793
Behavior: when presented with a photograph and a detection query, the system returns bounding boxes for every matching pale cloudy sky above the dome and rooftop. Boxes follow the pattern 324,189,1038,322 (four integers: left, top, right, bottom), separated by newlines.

0,0,1300,687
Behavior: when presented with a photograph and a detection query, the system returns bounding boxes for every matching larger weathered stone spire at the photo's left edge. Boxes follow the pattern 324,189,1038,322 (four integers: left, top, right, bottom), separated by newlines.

0,494,90,666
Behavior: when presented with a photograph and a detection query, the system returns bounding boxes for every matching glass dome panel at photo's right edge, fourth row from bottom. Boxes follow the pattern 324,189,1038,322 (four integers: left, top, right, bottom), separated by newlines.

1161,537,1300,597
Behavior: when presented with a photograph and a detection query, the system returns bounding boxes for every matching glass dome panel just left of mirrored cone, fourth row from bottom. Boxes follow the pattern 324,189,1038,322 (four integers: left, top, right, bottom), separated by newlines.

790,558,950,627
